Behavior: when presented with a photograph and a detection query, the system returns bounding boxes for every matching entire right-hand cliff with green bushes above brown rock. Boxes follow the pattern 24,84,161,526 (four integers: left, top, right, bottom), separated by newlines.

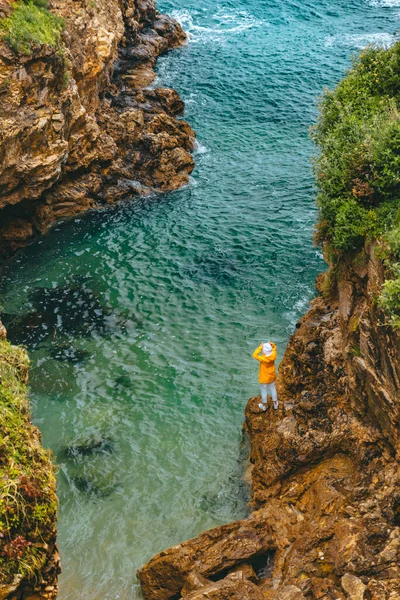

139,44,400,600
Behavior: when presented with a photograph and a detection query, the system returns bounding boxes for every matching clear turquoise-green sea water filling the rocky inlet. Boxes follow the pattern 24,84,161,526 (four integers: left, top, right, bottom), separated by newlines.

2,0,400,600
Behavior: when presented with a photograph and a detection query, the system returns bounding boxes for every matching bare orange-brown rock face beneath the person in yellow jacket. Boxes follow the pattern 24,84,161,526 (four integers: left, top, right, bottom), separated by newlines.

139,247,400,600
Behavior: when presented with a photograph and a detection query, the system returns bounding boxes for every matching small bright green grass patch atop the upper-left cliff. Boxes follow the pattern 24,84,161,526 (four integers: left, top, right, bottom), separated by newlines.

0,0,64,54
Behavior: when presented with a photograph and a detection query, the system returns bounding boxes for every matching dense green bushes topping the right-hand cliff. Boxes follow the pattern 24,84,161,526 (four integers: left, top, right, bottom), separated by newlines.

312,42,400,327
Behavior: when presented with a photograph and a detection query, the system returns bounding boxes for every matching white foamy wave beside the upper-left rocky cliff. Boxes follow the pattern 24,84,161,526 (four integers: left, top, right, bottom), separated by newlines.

171,9,268,43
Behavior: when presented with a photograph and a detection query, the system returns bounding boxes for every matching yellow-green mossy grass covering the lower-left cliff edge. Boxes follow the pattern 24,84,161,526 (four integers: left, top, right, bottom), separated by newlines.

0,341,57,585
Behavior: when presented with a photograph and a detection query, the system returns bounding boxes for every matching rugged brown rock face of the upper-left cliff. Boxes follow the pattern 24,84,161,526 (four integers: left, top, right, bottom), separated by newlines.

0,0,194,258
